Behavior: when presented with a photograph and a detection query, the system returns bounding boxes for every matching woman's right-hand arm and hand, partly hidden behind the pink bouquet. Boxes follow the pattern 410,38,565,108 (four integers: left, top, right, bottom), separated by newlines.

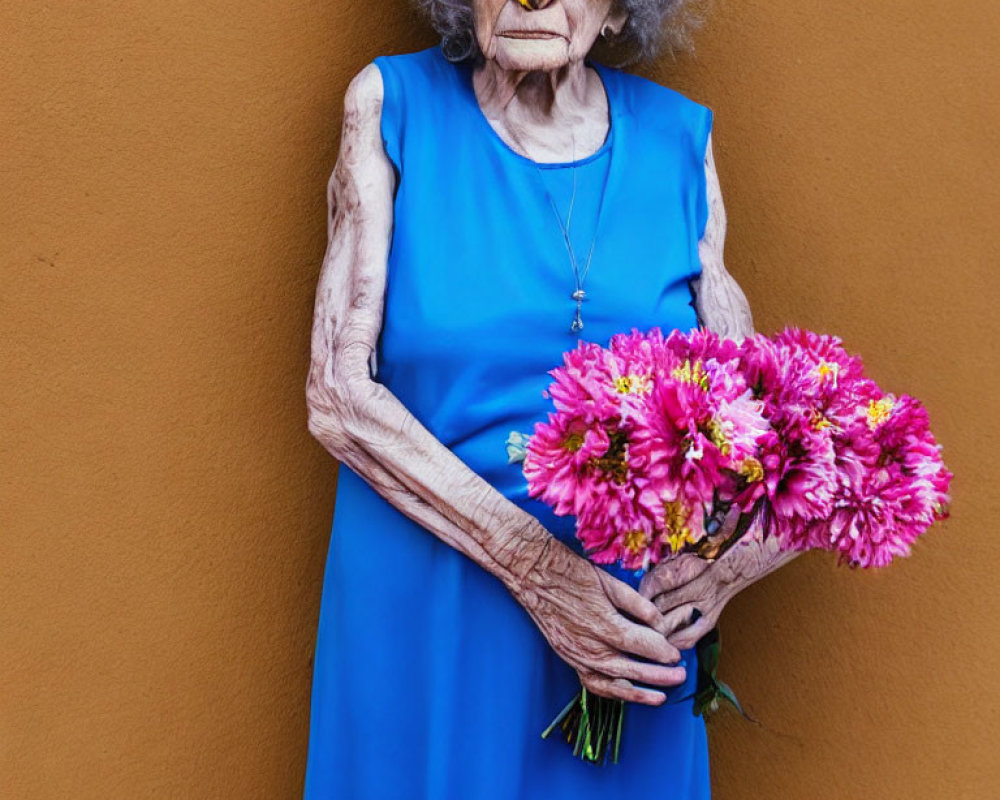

639,134,799,650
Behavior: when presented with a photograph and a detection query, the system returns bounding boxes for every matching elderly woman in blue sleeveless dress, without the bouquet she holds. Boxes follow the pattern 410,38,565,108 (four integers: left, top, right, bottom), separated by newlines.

305,0,793,800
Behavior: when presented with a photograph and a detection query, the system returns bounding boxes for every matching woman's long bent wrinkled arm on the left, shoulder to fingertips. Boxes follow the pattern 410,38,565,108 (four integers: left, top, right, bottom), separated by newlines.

306,64,684,705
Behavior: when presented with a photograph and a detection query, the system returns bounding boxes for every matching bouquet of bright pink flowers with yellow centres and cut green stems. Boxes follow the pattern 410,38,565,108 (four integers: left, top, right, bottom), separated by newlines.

506,328,952,763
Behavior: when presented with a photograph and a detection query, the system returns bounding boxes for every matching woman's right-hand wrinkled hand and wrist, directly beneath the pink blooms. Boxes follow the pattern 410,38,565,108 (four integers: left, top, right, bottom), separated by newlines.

639,510,800,650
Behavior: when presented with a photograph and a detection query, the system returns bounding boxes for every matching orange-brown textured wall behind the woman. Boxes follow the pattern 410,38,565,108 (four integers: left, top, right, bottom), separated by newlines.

0,0,1000,800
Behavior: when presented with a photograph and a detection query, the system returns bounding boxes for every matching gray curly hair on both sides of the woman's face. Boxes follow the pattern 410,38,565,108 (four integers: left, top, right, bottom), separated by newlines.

414,0,704,67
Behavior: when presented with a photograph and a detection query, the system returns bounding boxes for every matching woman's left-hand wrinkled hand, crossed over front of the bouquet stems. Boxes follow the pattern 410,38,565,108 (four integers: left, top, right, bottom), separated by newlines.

513,537,685,705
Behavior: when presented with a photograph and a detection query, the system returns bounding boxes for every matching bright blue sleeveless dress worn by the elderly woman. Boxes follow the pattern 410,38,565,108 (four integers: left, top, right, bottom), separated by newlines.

304,46,712,800
